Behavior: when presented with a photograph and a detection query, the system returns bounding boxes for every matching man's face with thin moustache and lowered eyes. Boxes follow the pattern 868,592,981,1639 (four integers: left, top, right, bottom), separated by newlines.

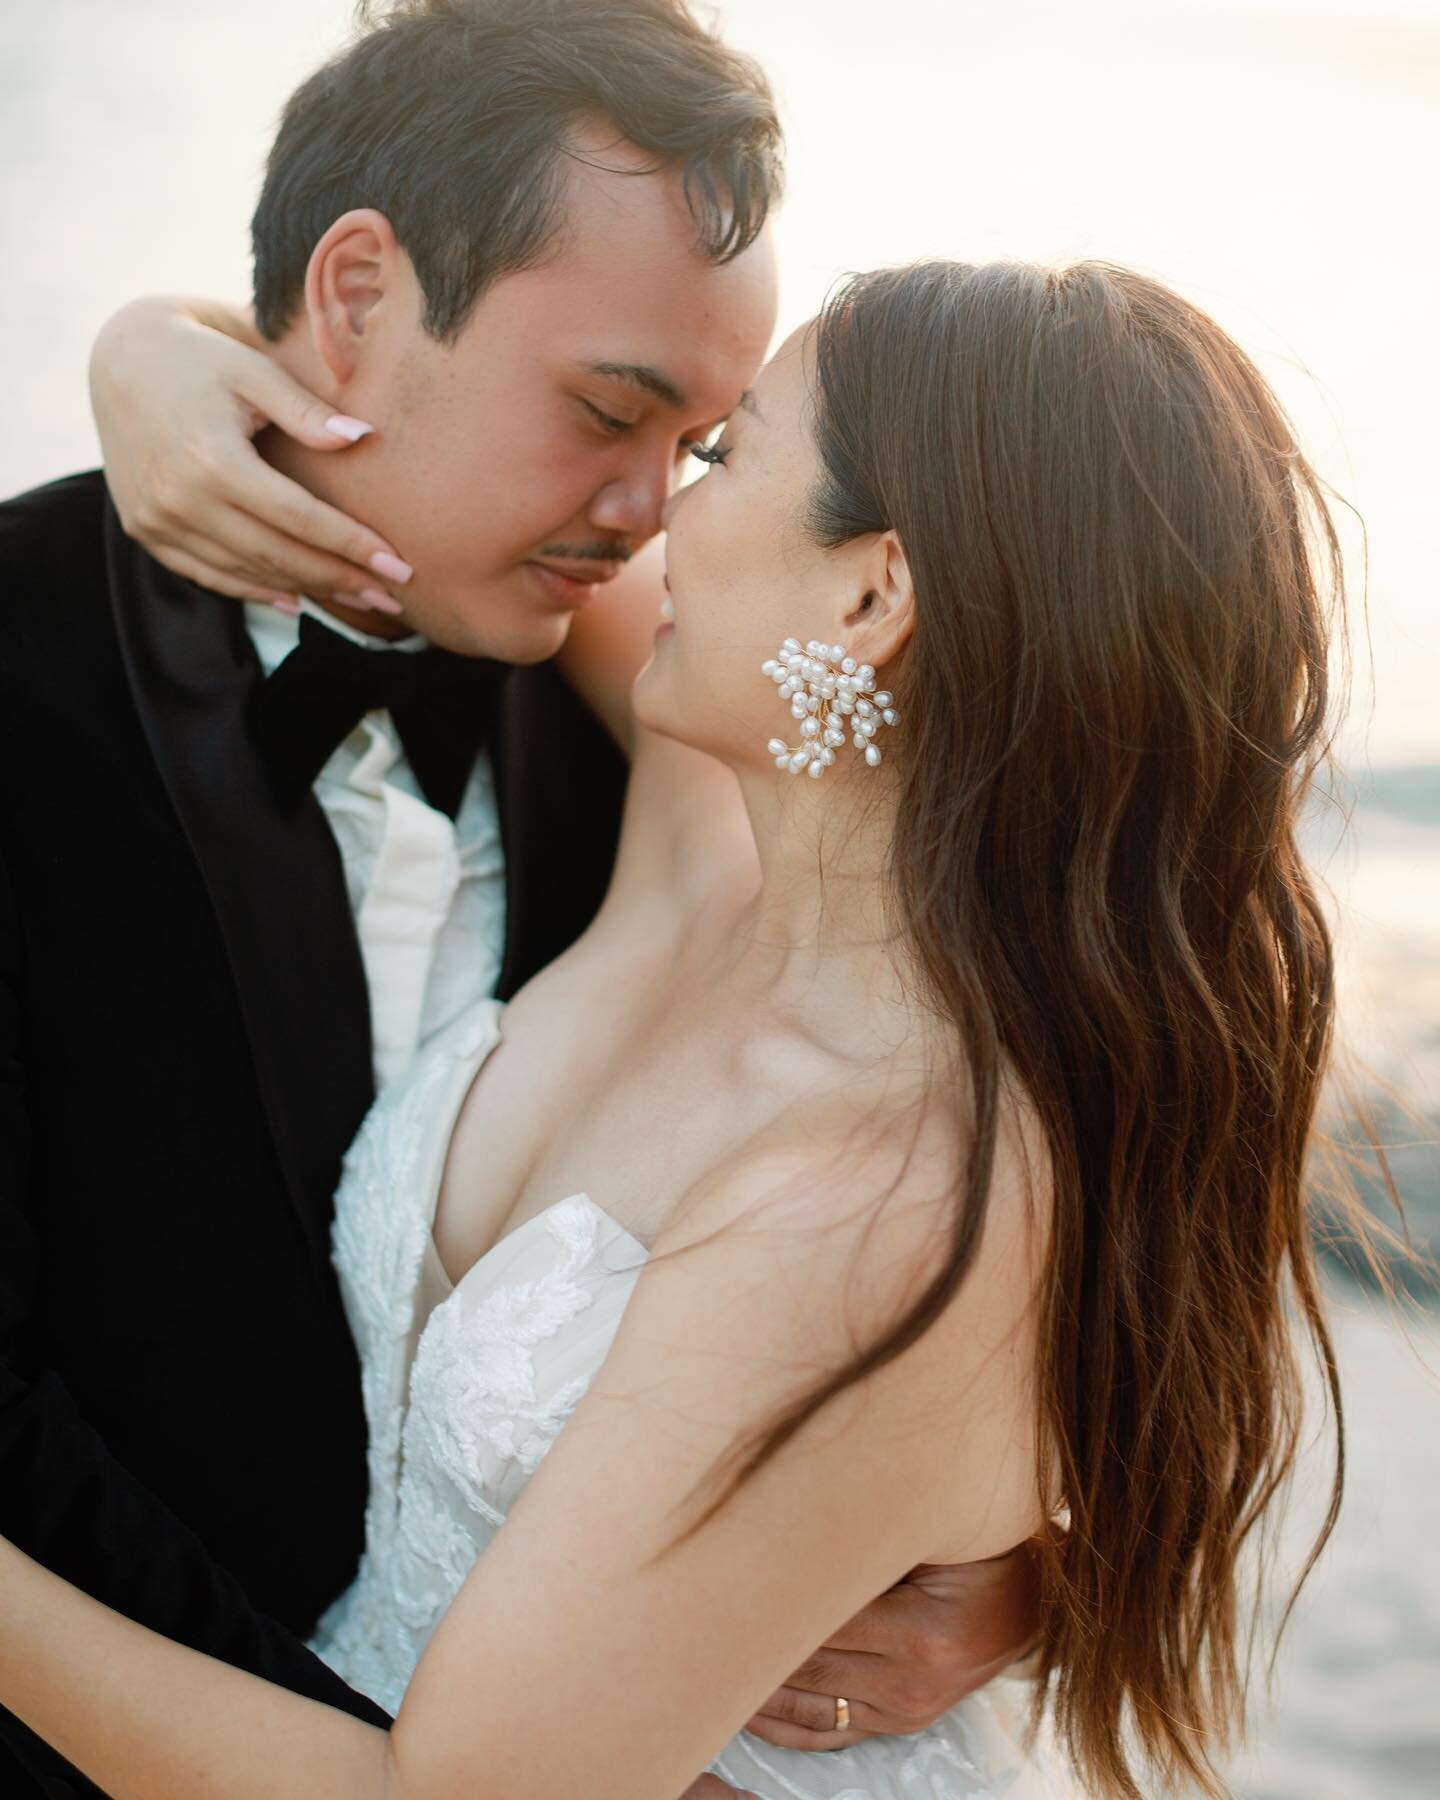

302,139,776,662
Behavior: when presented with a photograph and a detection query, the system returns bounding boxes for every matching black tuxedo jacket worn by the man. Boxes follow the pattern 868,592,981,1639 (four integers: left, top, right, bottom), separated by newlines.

0,473,625,1796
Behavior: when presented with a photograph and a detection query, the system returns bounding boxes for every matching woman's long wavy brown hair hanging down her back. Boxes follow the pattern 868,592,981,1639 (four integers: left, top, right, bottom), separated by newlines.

720,263,1343,1795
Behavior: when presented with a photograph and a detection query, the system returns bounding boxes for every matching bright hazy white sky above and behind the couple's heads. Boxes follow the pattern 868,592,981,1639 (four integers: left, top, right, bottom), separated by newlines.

11,0,1440,763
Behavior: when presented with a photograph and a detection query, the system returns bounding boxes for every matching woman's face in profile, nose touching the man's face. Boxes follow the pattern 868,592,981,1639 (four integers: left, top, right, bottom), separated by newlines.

635,328,862,769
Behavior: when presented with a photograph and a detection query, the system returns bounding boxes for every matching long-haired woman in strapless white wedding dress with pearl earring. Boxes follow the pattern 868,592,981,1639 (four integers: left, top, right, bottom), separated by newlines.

0,263,1334,1800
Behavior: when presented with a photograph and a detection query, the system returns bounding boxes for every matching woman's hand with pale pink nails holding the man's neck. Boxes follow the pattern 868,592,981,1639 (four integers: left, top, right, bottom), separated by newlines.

90,297,405,610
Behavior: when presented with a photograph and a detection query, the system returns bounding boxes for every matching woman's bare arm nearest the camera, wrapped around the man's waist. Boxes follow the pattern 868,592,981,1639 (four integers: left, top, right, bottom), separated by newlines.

0,1109,1035,1800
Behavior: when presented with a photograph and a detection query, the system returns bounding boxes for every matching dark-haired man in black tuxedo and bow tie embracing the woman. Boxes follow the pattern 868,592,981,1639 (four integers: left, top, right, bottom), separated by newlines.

0,0,1026,1796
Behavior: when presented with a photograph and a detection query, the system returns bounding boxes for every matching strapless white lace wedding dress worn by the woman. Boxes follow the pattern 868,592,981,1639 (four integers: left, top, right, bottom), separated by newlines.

313,1001,1076,1800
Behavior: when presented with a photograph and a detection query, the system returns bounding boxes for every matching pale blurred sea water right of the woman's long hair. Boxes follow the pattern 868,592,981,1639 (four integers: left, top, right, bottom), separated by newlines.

1231,788,1440,1800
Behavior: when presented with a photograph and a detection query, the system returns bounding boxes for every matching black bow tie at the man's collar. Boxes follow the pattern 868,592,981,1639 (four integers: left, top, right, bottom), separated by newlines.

256,617,508,819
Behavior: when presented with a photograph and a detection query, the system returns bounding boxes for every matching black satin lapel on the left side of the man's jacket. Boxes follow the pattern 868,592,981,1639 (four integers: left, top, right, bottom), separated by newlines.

106,506,373,1258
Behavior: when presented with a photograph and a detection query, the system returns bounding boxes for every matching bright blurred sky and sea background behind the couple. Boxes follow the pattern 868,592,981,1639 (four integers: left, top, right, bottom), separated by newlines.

0,0,1440,1800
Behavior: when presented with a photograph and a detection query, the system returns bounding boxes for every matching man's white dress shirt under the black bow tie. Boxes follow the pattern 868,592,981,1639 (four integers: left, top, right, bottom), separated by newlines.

245,599,506,1087
